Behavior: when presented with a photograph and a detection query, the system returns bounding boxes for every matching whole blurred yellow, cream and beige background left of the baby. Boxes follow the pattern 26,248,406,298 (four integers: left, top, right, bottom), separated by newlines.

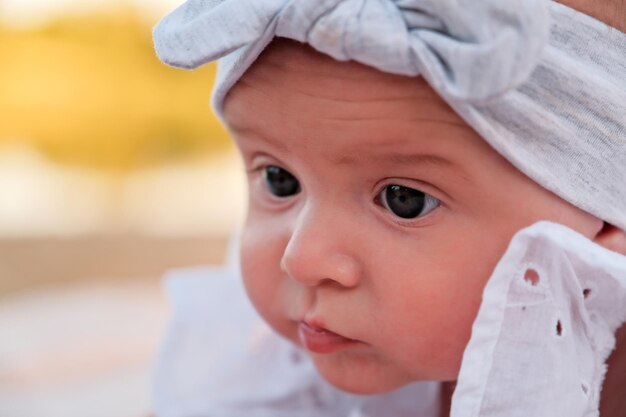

0,0,245,417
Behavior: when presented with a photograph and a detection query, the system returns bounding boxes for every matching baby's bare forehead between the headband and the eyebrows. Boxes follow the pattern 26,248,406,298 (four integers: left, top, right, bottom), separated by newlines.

224,39,492,176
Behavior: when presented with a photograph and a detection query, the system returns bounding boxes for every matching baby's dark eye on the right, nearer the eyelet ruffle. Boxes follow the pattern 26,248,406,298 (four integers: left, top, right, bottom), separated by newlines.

378,184,441,219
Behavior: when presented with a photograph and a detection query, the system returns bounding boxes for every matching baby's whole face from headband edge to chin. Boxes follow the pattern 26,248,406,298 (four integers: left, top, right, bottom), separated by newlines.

225,41,592,393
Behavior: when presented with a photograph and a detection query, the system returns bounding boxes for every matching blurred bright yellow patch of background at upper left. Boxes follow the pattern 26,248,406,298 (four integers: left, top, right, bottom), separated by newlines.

0,6,228,171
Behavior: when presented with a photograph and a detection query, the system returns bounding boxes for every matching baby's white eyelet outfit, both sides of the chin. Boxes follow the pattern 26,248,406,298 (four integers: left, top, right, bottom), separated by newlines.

154,222,626,417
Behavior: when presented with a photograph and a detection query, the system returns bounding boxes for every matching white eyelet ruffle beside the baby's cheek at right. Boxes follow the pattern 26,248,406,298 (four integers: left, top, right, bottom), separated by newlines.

451,222,626,417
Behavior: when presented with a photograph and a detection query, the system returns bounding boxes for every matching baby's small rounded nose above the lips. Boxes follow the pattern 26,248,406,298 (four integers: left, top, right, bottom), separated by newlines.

280,204,363,287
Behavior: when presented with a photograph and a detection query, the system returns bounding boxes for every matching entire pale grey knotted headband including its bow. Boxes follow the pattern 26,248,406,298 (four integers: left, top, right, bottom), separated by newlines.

154,0,626,230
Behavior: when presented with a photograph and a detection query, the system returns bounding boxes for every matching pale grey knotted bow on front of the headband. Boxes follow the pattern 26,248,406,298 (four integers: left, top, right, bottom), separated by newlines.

154,0,550,102
